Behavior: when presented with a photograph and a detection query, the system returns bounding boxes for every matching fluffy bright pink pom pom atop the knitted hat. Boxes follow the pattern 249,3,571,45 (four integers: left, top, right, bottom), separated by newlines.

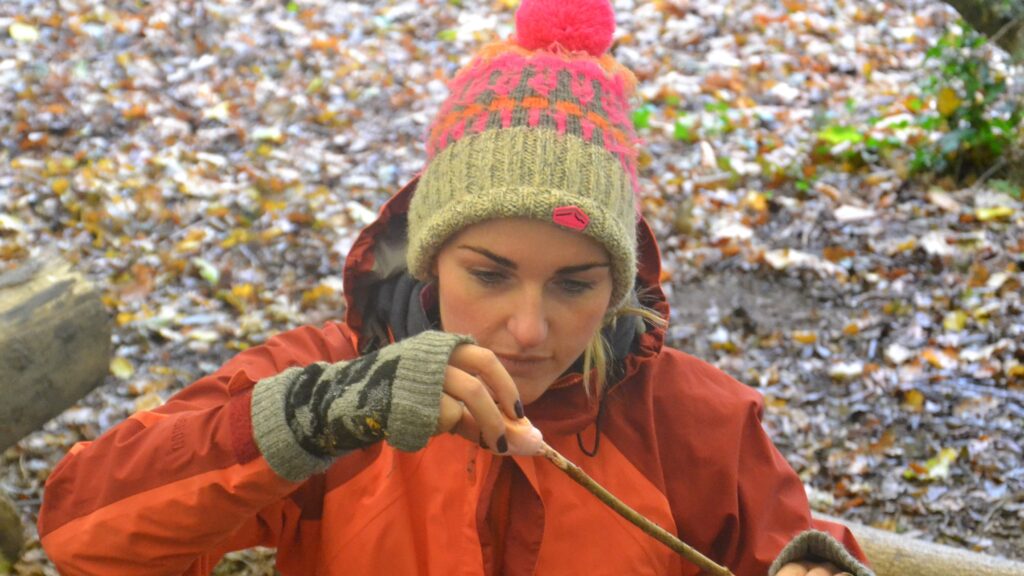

515,0,615,56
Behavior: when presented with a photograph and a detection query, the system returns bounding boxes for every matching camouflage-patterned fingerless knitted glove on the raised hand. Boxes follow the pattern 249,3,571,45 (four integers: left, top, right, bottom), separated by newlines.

252,331,473,482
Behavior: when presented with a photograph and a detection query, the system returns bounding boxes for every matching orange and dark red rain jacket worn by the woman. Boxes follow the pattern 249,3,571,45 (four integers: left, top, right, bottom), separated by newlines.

39,177,863,576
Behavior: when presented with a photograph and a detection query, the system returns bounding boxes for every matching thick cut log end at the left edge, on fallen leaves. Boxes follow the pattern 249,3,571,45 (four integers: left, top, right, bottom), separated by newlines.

0,256,112,450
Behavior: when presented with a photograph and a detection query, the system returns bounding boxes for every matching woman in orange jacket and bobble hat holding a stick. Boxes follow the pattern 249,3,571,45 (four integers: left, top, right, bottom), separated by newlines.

39,0,870,576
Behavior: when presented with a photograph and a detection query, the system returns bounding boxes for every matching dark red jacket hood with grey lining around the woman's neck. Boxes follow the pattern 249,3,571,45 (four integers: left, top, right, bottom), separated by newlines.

343,177,669,434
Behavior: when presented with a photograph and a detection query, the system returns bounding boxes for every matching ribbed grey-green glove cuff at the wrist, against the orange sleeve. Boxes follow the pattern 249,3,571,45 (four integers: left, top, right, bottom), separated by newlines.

251,367,334,482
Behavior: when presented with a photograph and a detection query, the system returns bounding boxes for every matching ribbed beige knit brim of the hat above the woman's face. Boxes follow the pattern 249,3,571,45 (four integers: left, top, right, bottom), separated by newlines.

407,127,636,310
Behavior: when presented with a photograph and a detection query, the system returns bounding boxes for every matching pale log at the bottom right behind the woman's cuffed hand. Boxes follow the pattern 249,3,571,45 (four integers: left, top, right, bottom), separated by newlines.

814,512,1024,576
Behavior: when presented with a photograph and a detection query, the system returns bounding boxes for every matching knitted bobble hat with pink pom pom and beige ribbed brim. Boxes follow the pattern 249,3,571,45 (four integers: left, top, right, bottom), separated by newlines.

408,0,638,310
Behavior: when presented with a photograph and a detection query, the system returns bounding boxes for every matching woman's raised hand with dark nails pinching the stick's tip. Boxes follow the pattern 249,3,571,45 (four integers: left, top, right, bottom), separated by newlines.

437,344,543,456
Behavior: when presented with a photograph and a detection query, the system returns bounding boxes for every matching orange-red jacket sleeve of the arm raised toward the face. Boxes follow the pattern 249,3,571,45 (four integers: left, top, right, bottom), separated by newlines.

38,324,357,576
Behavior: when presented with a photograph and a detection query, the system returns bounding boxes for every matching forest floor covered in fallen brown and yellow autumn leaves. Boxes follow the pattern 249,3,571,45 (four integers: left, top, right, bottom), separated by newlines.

0,0,1024,575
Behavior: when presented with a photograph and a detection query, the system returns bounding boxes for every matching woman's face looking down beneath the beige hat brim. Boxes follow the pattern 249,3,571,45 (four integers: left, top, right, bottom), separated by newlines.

436,218,612,404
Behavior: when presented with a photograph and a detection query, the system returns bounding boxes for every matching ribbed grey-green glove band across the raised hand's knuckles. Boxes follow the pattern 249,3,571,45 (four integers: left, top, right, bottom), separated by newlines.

387,330,474,452
